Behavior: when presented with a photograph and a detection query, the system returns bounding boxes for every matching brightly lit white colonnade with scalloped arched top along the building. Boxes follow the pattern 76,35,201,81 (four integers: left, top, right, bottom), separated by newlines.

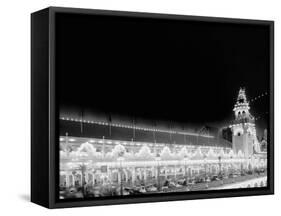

60,143,267,187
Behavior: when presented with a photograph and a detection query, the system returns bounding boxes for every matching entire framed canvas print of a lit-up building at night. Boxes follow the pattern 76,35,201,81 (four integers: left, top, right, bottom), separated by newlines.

31,7,274,208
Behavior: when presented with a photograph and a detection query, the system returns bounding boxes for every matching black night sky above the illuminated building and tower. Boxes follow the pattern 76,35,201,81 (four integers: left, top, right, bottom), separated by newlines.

56,14,269,137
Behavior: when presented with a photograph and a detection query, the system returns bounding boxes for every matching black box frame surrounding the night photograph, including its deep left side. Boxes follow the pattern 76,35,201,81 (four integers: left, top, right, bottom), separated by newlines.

31,7,274,208
